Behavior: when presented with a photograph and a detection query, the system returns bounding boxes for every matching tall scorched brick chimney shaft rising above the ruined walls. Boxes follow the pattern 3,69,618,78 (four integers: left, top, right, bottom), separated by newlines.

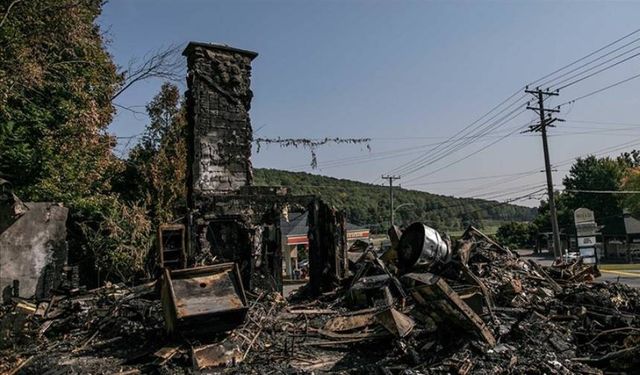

183,42,258,208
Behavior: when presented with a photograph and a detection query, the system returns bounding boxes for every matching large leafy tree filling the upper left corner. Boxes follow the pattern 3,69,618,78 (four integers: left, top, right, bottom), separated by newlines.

0,0,121,202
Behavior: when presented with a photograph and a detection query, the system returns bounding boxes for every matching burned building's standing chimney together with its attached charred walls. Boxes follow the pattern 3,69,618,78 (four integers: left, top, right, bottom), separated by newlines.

183,42,347,293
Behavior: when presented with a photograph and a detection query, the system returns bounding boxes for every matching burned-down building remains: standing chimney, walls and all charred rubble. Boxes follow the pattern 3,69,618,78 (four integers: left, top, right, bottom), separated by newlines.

0,43,640,375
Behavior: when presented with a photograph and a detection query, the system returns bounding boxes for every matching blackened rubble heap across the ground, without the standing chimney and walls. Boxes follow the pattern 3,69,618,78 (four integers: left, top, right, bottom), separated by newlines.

0,228,640,375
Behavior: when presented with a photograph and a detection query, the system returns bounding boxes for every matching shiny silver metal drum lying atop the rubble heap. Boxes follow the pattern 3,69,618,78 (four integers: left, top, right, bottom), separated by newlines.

398,223,451,270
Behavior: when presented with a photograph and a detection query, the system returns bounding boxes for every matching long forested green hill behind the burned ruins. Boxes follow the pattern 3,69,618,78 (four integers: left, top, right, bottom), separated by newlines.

254,168,537,232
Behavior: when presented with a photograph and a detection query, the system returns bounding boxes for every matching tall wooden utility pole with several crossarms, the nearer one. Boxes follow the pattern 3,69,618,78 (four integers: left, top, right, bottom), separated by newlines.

525,87,562,259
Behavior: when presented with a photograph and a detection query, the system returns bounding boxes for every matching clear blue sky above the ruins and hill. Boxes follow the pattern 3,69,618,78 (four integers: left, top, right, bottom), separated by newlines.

99,0,640,205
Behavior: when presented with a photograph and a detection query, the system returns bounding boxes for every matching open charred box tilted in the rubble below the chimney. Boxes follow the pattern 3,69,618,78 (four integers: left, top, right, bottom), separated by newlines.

162,263,248,335
